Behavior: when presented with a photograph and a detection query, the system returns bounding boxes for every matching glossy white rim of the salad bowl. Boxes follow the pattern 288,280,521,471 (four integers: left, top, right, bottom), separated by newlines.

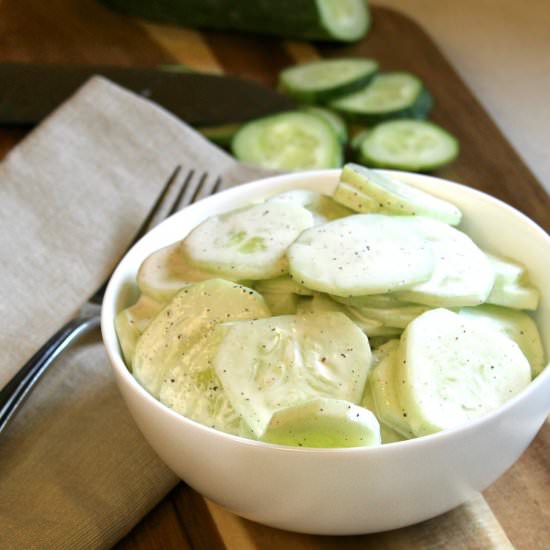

101,169,550,455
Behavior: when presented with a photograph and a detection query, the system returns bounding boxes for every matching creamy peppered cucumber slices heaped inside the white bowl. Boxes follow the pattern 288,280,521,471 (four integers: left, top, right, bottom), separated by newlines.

116,164,546,448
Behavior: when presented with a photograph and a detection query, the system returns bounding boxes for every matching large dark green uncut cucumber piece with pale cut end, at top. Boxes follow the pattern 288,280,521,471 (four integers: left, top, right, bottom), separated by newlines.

102,0,370,42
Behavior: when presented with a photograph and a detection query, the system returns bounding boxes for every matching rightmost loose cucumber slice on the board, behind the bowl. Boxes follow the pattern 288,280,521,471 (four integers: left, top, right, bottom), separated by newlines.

359,119,459,172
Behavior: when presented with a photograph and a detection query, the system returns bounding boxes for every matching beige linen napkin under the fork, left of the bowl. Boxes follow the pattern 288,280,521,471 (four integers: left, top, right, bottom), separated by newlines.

0,77,272,550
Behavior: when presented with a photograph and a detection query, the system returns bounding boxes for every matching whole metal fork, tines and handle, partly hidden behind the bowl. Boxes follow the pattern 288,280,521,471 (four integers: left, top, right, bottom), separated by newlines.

0,166,222,433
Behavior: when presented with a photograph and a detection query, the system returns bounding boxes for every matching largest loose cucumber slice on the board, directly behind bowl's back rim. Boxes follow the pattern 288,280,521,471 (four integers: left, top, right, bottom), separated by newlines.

231,111,342,170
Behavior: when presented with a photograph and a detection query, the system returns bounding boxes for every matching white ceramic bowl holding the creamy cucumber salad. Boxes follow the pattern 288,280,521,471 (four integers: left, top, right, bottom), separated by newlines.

102,170,550,534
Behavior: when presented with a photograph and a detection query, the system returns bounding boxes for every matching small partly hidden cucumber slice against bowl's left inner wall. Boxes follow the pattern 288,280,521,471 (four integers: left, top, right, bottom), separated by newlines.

115,295,163,371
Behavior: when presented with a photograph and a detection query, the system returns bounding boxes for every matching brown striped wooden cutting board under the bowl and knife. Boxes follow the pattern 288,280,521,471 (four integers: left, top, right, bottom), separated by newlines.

0,0,550,550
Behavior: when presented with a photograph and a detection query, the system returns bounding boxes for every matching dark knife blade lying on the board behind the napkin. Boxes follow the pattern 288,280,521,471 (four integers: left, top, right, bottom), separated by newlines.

0,63,294,126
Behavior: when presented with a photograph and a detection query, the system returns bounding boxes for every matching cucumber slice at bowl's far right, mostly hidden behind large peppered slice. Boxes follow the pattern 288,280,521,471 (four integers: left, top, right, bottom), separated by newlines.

458,304,544,378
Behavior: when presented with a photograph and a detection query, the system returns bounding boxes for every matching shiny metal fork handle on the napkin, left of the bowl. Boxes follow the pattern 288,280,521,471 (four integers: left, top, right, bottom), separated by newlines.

0,314,100,433
